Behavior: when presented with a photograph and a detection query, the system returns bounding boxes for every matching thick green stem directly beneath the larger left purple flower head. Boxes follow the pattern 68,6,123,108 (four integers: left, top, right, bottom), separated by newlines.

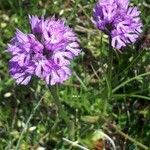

49,85,69,124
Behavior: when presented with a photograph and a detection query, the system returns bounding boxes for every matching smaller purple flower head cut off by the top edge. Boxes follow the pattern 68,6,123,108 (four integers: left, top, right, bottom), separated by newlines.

92,0,142,50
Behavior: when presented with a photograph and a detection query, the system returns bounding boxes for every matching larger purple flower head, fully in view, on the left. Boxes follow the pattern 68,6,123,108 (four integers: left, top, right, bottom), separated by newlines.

8,16,80,85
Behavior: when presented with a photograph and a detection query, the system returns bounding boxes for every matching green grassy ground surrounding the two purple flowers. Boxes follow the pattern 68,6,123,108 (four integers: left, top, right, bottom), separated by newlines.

0,0,150,150
